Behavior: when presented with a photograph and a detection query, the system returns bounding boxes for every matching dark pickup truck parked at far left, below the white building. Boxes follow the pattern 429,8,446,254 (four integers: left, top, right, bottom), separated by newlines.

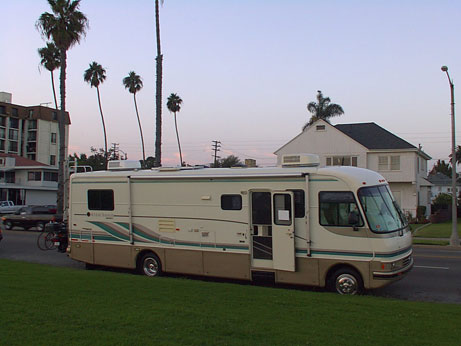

2,205,58,231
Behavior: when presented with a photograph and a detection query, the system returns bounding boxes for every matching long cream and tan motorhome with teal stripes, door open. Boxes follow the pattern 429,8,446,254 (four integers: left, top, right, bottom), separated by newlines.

68,155,413,294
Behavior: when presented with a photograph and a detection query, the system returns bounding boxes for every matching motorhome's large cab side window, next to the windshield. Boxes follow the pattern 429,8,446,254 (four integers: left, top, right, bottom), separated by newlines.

319,191,363,227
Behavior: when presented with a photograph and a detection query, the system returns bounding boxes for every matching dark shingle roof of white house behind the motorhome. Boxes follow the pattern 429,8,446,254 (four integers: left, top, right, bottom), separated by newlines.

335,123,417,149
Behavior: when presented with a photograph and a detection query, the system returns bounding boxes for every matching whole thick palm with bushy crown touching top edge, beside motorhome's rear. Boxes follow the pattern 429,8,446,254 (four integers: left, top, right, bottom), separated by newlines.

36,0,88,214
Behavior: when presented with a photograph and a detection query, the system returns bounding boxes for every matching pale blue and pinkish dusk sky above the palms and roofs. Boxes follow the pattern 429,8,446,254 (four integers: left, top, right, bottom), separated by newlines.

0,0,461,169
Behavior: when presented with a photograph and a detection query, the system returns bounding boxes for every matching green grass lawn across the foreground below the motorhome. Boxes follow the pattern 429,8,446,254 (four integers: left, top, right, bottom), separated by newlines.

0,260,461,345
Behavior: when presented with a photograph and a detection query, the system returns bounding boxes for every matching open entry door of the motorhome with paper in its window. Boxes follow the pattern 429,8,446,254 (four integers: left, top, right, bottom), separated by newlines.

272,191,295,272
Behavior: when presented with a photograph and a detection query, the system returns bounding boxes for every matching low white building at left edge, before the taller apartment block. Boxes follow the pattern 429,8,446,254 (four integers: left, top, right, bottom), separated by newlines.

0,153,58,205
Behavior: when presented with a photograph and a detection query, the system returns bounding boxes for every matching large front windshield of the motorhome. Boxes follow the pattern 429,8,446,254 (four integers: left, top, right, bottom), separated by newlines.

359,185,407,233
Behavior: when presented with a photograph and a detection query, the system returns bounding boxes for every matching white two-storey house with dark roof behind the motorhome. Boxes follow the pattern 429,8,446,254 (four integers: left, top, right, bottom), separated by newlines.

274,120,432,216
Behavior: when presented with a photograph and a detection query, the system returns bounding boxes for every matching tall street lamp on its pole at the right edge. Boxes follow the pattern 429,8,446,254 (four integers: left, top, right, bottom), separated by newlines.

442,66,459,246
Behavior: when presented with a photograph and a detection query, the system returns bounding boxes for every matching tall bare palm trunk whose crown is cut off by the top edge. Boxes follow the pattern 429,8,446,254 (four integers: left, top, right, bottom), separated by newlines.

155,0,163,167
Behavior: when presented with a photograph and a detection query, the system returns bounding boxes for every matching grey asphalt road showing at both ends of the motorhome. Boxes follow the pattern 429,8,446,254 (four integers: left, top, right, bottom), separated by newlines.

0,230,461,304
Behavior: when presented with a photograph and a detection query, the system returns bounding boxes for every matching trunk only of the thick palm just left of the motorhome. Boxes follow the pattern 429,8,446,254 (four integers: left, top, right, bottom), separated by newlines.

56,49,67,215
